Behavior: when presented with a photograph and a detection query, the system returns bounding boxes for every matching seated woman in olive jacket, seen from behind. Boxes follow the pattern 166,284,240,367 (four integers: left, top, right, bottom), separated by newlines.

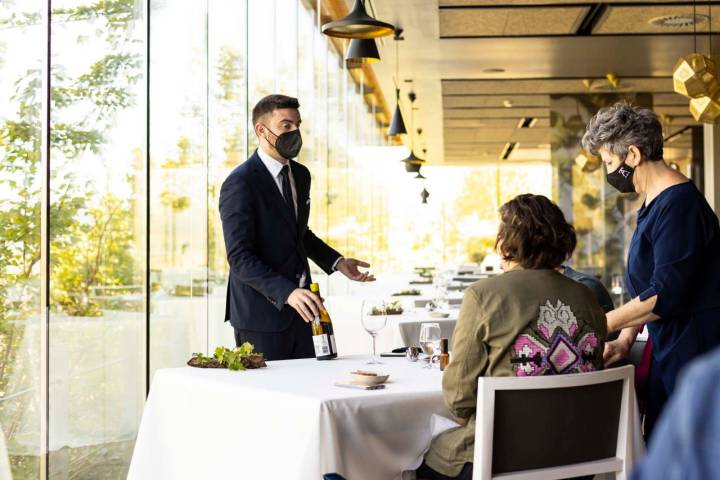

417,194,607,480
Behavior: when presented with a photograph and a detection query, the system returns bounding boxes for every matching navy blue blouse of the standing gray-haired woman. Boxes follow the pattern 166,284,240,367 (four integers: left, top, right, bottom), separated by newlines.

625,182,720,393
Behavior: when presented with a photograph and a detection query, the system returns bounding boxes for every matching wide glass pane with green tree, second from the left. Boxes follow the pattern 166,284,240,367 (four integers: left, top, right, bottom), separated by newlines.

49,0,146,478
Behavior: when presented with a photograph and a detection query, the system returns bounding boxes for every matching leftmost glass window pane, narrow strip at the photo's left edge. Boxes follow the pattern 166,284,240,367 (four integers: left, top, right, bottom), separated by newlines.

0,0,47,478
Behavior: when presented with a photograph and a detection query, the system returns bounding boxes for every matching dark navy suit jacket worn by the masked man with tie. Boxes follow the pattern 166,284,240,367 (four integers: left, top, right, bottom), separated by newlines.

220,152,340,332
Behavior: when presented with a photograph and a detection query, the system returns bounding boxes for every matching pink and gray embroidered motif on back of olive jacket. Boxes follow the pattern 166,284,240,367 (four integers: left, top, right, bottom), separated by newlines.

510,300,599,377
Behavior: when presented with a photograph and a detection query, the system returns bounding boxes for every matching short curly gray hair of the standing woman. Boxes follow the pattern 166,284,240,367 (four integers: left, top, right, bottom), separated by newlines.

582,102,663,160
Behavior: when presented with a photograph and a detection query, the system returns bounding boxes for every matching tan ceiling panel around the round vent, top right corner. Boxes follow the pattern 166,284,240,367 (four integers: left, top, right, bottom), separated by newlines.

593,2,720,35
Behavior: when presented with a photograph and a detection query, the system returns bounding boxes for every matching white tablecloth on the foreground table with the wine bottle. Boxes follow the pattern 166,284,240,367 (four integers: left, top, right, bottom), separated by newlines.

128,357,456,480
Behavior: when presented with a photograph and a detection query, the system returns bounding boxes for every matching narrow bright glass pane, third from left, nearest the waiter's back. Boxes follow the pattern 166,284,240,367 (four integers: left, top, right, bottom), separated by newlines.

150,0,208,378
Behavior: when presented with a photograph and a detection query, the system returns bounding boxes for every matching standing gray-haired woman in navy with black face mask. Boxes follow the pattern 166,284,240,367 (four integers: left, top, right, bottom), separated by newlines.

582,103,720,438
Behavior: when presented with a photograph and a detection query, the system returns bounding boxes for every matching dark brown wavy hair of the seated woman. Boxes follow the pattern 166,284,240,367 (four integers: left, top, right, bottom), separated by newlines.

495,193,577,269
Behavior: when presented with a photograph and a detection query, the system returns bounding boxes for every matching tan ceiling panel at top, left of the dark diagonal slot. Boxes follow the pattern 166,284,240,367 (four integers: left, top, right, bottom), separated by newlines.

440,6,590,38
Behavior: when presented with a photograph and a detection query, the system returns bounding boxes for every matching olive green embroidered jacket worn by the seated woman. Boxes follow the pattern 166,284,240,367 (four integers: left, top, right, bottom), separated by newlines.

425,267,607,476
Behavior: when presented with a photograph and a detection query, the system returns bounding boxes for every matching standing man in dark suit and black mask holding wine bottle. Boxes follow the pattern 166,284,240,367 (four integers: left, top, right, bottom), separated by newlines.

220,95,375,360
